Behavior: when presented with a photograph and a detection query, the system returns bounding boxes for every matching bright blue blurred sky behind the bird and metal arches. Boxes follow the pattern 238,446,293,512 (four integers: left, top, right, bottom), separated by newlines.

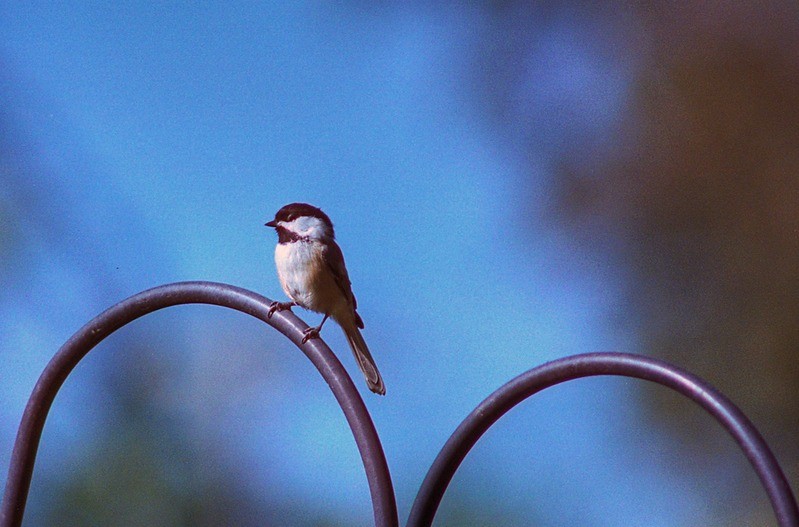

0,2,764,526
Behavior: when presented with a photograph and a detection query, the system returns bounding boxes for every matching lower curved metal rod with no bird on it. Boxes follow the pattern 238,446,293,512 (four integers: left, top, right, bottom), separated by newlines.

407,353,799,527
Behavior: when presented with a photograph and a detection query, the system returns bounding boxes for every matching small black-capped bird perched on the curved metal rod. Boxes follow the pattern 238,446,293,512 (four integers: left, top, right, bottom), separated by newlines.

264,203,386,395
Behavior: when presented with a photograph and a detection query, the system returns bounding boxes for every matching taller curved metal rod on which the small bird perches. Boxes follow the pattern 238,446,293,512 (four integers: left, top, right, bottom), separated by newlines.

0,282,399,527
